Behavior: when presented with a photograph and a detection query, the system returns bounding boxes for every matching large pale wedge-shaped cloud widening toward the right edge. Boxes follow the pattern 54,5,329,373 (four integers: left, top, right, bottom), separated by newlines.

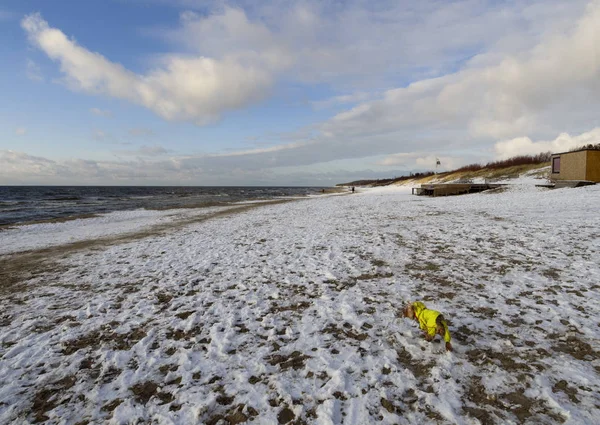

312,1,600,161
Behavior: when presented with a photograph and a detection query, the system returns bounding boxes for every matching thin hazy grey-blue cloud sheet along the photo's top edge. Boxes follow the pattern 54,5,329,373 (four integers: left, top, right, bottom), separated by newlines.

163,0,585,88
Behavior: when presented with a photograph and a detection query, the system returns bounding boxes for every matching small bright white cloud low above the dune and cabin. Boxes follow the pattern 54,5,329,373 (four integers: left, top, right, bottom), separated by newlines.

494,128,600,159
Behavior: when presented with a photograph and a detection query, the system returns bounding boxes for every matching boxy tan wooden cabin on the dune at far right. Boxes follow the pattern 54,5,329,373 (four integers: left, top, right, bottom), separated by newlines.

550,149,600,183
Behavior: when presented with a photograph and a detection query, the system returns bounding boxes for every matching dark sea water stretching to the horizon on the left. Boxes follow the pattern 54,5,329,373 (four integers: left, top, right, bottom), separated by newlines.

0,186,322,225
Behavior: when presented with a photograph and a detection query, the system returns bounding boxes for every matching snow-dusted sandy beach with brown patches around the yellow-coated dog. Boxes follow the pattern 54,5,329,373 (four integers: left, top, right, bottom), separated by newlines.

0,184,600,425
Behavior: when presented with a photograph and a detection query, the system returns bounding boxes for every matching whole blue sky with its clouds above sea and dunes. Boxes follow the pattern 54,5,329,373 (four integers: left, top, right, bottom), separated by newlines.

0,0,600,186
